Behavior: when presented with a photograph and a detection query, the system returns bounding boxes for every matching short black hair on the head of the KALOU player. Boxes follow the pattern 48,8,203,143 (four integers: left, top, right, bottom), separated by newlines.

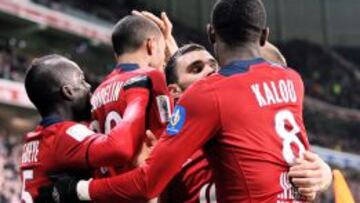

211,0,266,47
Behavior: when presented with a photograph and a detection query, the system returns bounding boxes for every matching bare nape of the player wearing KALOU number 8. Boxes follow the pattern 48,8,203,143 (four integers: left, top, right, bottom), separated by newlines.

218,46,261,66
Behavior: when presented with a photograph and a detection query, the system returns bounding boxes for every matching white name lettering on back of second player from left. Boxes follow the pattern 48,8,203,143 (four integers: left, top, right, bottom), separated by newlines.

91,81,124,110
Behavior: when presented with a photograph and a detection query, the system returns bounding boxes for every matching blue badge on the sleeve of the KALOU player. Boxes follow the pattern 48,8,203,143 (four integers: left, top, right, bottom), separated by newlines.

166,105,186,135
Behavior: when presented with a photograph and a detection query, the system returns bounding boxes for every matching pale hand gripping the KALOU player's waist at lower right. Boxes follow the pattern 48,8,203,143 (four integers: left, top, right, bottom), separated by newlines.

289,151,332,200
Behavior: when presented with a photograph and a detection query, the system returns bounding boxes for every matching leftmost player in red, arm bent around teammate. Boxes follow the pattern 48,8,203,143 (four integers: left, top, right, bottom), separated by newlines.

20,55,148,203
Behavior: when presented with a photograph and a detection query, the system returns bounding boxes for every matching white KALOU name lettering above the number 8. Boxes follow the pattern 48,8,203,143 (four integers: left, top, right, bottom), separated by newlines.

251,80,297,107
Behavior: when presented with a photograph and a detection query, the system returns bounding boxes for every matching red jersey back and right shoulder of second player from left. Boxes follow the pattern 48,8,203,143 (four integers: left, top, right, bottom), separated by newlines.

91,64,171,135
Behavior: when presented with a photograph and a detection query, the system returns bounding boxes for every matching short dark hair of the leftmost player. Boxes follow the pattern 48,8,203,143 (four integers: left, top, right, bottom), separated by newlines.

25,54,68,115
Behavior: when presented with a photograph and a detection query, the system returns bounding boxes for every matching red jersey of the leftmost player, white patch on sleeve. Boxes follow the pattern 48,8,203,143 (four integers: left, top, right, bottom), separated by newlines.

20,114,146,203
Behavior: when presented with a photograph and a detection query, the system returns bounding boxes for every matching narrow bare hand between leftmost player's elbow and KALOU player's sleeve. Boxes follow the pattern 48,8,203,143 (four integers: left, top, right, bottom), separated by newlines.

133,130,157,167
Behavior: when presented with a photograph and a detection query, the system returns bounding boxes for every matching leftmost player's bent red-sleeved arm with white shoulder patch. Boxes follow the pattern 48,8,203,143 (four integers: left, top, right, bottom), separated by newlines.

55,78,149,168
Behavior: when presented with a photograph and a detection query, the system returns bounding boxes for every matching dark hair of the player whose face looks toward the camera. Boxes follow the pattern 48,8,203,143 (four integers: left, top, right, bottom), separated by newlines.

165,43,206,84
